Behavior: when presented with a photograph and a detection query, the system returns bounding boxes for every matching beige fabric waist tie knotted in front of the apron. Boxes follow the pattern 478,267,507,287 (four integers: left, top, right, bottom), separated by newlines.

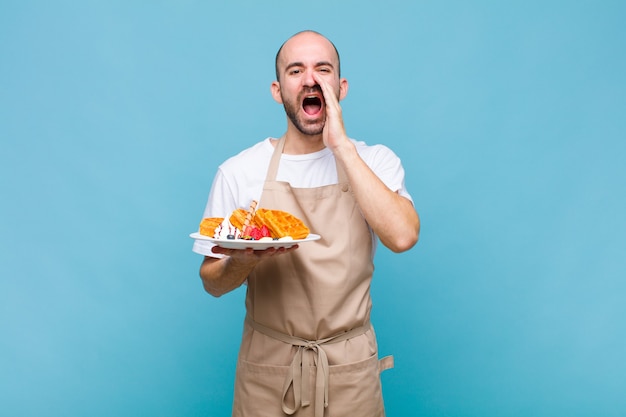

246,316,371,417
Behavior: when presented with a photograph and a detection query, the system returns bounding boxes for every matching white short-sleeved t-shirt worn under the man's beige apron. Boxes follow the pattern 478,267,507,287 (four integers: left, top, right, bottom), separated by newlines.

193,138,413,256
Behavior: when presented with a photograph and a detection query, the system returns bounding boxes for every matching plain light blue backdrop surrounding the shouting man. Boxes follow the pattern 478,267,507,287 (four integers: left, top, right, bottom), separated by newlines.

0,0,626,417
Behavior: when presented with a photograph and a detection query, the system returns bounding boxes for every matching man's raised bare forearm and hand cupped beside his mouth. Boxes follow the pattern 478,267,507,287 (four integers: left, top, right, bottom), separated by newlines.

314,74,420,252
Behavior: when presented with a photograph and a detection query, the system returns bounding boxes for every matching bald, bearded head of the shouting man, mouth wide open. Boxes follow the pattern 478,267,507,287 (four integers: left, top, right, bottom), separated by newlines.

273,33,343,135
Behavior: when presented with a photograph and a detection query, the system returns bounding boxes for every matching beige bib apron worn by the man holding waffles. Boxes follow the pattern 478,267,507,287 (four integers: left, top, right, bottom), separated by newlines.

233,138,393,417
